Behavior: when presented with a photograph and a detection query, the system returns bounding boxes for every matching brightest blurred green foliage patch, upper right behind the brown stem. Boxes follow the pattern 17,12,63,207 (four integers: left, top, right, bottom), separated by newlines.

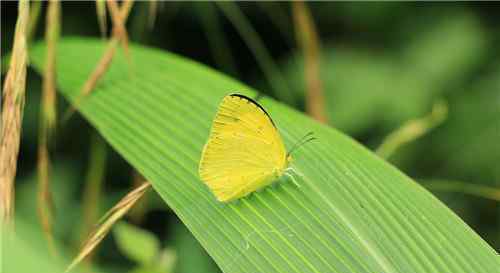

283,13,487,135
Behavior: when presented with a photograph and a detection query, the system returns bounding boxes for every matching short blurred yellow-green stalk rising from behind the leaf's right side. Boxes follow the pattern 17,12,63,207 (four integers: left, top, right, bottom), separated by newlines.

376,100,448,159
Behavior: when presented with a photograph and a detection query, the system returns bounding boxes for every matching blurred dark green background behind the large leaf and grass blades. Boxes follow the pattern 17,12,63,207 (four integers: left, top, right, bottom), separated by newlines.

1,1,500,272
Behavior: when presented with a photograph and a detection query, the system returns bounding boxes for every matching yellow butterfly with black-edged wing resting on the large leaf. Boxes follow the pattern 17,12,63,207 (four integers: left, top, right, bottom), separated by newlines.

198,94,310,202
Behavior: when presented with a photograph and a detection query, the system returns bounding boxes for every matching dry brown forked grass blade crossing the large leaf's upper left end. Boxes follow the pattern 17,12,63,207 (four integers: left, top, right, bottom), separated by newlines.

63,0,133,122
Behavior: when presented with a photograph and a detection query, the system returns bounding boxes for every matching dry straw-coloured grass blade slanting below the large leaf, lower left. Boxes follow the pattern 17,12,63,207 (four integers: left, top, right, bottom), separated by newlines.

65,182,151,272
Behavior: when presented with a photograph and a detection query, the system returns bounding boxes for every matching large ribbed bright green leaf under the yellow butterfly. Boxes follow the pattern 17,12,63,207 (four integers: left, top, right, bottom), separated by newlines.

32,38,499,273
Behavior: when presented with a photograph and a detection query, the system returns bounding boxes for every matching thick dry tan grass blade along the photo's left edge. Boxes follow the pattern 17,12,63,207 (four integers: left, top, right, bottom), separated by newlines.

0,0,29,225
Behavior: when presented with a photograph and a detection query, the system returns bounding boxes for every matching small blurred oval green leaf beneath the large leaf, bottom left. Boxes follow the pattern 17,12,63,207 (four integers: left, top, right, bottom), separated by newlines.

113,222,160,265
